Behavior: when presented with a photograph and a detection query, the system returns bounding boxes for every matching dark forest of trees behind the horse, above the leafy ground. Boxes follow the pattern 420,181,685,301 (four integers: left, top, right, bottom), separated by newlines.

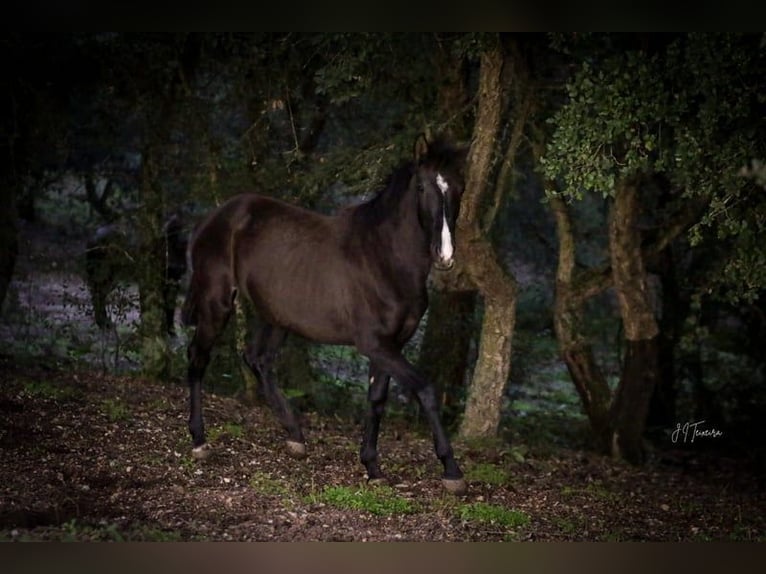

0,33,766,484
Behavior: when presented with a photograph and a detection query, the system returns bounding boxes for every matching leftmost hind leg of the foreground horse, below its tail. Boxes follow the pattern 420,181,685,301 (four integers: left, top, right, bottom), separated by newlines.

187,286,234,459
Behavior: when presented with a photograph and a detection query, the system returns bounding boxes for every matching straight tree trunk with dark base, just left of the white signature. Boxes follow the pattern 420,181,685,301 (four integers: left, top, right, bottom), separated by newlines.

609,179,659,464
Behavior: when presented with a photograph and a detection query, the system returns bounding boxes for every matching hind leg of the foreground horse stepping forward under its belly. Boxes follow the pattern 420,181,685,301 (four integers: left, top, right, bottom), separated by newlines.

244,324,306,458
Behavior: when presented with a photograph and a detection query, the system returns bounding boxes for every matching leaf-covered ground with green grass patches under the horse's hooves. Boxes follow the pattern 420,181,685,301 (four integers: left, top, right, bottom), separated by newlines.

0,357,766,541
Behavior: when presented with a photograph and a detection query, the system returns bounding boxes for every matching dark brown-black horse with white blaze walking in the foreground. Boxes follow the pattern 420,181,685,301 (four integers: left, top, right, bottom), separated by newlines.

183,137,466,493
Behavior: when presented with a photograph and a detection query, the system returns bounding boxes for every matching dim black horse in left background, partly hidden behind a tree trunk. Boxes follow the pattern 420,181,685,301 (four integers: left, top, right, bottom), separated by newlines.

85,215,188,335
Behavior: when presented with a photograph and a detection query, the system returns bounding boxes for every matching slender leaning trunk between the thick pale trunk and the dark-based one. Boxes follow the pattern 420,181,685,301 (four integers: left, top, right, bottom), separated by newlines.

550,197,611,452
